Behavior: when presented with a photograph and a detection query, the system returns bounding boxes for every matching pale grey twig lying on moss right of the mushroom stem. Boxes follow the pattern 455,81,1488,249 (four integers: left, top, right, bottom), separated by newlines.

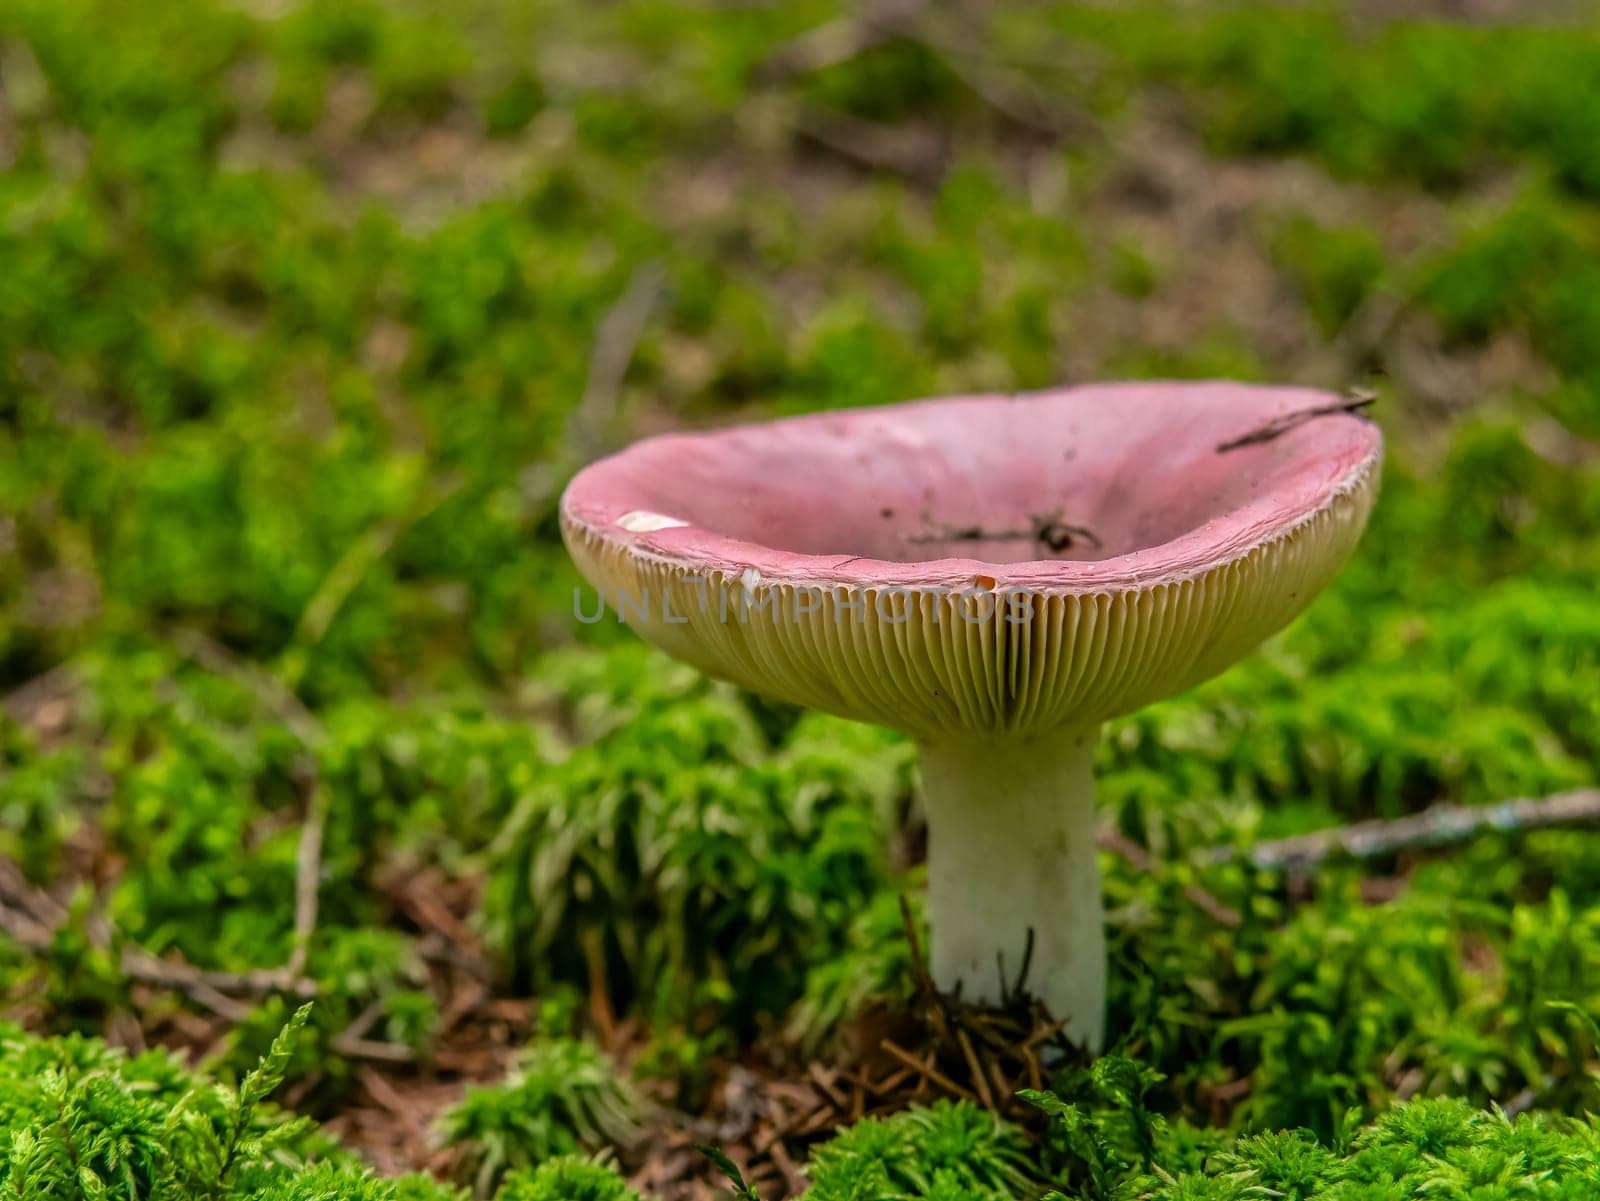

1197,788,1600,872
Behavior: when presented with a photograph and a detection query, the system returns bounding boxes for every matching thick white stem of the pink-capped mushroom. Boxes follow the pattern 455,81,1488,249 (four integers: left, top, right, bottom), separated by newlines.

920,729,1106,1051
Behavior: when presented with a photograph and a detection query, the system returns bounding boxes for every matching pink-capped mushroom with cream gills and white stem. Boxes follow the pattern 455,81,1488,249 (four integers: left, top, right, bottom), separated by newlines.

562,382,1382,1049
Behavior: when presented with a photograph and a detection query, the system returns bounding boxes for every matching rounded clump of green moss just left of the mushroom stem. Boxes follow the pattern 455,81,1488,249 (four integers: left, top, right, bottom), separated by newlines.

485,654,907,1030
